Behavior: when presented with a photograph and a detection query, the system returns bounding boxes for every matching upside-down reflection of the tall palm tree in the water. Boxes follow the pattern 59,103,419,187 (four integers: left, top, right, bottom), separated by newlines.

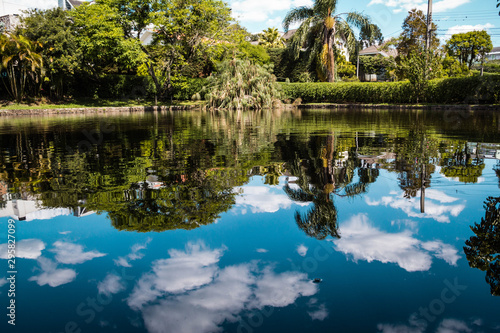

276,133,378,239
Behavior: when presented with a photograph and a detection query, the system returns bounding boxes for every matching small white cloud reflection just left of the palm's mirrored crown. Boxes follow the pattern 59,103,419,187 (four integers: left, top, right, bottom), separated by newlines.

235,186,309,213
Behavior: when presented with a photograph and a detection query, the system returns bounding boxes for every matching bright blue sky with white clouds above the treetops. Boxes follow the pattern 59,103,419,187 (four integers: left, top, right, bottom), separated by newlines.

0,0,500,46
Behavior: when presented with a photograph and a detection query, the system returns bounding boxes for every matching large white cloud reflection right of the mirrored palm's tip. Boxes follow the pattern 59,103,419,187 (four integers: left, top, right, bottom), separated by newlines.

331,214,459,272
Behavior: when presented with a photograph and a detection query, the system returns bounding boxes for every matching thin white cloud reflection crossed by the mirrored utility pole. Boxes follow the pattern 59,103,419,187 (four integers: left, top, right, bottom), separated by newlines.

365,189,465,223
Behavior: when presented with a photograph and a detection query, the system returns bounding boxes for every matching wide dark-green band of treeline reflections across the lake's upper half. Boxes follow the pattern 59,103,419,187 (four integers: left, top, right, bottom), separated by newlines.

0,110,500,232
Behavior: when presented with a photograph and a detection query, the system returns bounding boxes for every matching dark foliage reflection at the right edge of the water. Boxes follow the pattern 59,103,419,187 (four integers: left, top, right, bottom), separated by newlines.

464,197,500,296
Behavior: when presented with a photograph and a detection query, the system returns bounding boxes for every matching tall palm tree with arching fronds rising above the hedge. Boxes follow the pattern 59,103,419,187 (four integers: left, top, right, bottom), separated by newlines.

283,0,372,82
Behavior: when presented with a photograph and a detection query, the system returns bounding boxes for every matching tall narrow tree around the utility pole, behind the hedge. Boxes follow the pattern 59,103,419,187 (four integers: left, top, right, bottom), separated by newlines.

396,9,439,56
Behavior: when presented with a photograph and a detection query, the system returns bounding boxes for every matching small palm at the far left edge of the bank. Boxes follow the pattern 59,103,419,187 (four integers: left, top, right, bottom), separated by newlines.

0,34,43,103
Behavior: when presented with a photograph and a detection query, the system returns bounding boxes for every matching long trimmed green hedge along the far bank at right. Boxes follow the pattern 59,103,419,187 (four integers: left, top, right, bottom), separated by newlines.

280,75,500,104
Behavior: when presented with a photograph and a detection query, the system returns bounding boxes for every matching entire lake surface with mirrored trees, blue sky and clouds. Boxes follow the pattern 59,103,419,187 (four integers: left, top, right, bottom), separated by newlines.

0,110,500,333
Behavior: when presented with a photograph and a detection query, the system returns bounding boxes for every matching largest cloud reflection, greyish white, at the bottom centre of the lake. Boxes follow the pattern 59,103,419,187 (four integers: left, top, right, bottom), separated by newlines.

127,243,318,333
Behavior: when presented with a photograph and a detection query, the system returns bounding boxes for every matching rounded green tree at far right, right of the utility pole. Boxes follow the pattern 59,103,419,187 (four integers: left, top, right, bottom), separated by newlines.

446,30,493,69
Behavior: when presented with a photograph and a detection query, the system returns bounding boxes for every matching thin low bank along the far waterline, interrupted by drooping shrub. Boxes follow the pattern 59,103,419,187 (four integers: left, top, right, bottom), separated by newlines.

0,103,500,117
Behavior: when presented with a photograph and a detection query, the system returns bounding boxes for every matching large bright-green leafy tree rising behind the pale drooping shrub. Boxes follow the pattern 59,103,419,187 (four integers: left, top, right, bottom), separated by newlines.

98,0,235,98
